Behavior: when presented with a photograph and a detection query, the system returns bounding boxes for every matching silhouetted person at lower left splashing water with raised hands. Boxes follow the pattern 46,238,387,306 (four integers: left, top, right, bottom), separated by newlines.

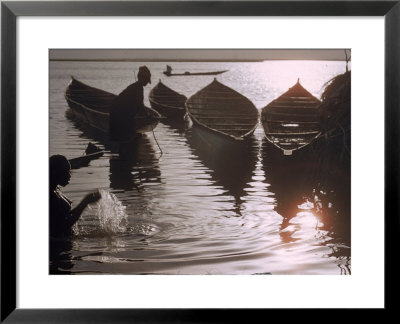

49,155,101,238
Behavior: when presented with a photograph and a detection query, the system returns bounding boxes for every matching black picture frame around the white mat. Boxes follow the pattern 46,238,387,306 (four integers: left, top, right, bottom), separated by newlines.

1,0,400,323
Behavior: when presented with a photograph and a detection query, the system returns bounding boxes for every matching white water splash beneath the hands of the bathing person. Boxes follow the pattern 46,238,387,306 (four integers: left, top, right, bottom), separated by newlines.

96,189,128,233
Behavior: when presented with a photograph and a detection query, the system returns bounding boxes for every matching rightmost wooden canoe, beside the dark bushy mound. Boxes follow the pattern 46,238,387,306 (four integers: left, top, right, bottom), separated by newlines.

261,80,321,155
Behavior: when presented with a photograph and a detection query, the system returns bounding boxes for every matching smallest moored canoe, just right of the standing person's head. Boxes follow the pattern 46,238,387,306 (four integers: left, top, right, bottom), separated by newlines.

149,80,187,119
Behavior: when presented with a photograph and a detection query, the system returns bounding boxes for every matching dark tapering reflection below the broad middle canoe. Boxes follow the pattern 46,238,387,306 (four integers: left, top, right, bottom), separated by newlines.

186,127,257,215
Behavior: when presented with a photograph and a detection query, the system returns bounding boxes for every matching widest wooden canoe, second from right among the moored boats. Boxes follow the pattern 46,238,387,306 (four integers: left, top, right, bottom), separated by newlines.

186,79,258,145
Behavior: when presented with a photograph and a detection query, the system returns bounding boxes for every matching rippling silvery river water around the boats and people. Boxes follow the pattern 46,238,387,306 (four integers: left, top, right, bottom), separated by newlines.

49,61,351,275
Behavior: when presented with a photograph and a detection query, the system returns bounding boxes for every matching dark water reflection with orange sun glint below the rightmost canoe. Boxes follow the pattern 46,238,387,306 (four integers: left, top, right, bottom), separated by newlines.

262,140,351,274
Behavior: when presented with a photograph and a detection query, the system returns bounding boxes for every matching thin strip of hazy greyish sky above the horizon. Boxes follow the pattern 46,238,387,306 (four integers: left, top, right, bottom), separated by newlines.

50,49,350,61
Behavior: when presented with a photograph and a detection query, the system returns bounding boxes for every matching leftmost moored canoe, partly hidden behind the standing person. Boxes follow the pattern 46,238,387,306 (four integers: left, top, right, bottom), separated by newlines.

65,77,161,134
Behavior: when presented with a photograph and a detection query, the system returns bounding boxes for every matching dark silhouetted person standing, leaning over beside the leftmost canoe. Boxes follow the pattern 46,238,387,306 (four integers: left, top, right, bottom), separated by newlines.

110,66,151,142
